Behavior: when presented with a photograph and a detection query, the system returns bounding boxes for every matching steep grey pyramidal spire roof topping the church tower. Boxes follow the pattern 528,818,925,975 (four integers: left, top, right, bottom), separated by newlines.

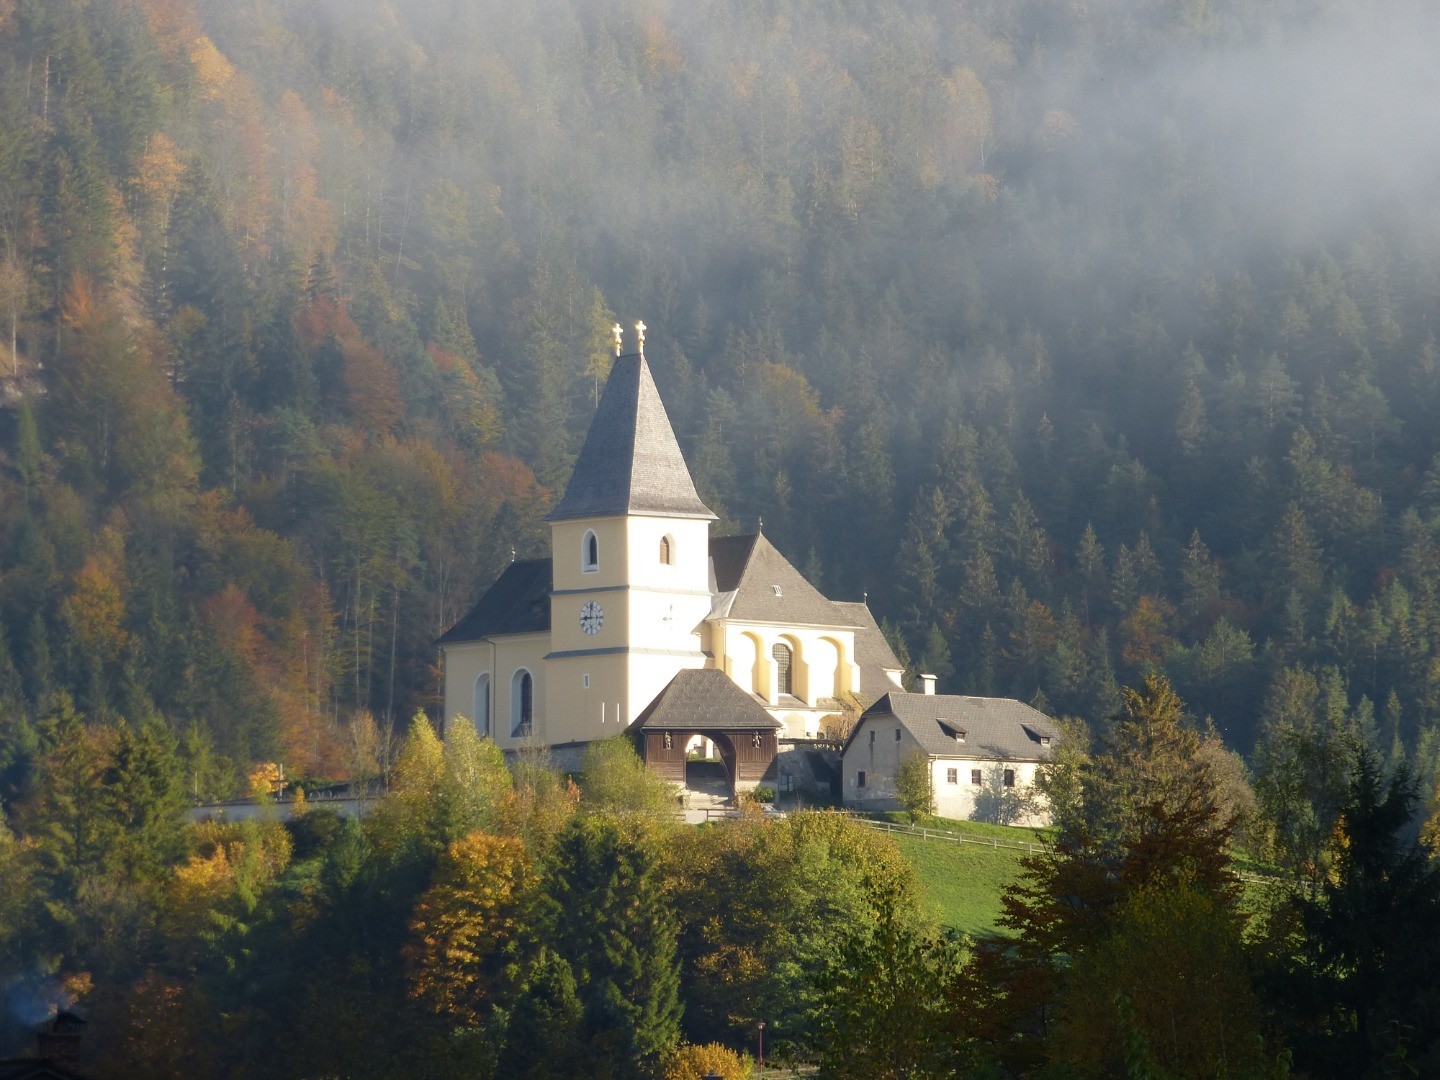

549,356,714,521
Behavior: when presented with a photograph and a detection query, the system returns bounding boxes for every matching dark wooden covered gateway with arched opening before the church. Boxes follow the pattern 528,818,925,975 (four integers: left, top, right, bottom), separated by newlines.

626,668,780,795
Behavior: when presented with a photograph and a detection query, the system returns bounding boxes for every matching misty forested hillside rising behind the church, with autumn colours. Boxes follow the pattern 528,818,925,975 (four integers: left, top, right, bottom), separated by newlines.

0,0,1440,795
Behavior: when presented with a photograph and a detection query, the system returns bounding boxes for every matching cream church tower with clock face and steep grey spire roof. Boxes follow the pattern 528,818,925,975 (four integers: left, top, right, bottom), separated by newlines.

544,333,716,744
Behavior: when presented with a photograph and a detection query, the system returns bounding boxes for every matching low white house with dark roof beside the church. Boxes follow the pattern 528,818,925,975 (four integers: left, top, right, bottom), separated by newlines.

842,688,1061,825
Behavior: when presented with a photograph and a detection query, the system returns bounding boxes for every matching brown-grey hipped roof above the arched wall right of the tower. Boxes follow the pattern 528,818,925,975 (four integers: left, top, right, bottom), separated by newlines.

710,533,857,626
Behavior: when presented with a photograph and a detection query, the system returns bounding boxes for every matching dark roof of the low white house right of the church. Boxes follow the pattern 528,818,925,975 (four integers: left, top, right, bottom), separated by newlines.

845,691,1061,762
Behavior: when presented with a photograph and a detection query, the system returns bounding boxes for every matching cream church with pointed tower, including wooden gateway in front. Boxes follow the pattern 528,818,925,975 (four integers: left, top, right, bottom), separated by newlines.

438,324,901,792
